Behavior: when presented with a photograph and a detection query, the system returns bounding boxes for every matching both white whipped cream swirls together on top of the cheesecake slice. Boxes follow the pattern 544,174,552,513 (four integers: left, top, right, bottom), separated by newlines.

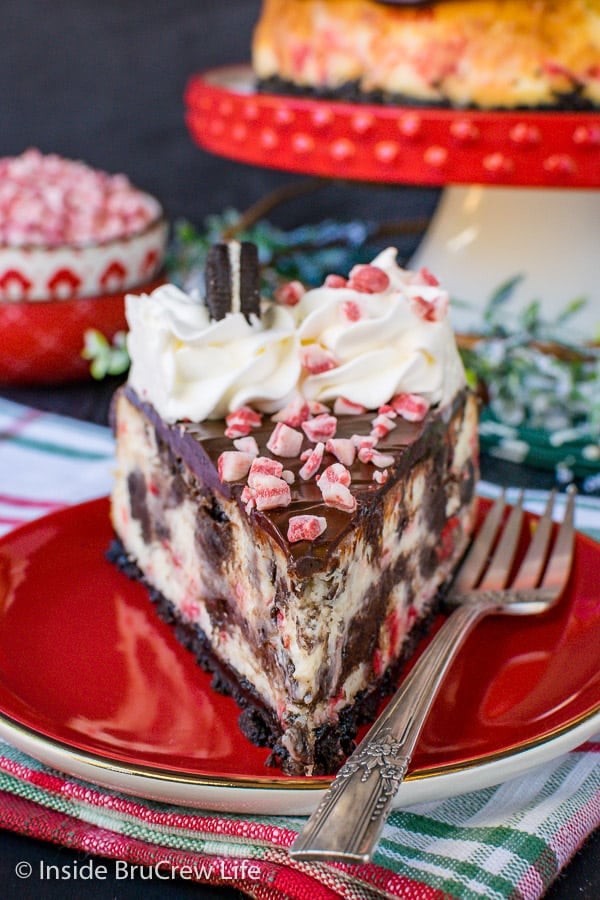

126,248,466,422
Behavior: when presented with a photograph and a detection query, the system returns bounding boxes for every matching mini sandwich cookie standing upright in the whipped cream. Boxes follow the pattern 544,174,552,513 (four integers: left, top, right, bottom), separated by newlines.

205,241,260,321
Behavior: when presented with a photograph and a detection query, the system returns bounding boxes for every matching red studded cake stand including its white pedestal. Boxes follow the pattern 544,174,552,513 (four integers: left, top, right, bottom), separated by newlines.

185,66,600,337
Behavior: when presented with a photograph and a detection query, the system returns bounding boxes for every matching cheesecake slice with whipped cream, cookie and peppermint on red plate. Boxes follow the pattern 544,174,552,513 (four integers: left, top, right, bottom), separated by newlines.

111,244,478,774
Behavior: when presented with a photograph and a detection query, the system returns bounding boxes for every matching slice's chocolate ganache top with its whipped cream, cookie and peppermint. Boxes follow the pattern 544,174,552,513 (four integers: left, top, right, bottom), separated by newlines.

126,244,466,575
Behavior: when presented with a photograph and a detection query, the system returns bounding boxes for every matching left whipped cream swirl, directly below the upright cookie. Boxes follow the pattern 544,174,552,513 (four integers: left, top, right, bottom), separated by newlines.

126,285,300,422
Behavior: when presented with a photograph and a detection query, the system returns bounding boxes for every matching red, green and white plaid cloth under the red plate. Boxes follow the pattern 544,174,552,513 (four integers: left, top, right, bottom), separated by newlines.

0,400,600,900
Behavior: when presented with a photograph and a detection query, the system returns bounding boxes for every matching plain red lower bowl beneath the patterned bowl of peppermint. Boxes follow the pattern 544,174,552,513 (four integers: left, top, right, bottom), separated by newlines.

0,277,164,385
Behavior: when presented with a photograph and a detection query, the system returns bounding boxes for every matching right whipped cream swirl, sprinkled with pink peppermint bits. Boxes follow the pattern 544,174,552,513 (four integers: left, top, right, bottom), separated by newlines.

294,247,465,409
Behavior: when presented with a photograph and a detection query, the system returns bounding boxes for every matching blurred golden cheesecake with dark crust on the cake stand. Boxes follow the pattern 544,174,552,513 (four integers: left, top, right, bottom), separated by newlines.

252,0,600,109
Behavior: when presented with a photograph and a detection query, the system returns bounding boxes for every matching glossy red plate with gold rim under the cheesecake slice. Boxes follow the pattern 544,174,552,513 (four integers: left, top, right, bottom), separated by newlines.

0,499,600,800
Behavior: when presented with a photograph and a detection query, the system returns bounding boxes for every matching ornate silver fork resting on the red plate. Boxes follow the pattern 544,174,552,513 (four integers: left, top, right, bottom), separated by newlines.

290,490,575,863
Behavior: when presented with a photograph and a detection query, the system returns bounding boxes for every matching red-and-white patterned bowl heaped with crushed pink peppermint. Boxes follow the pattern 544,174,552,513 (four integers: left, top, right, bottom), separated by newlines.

0,149,168,303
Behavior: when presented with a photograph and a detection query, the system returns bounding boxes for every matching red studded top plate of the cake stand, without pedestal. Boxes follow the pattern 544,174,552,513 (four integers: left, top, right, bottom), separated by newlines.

185,66,600,187
